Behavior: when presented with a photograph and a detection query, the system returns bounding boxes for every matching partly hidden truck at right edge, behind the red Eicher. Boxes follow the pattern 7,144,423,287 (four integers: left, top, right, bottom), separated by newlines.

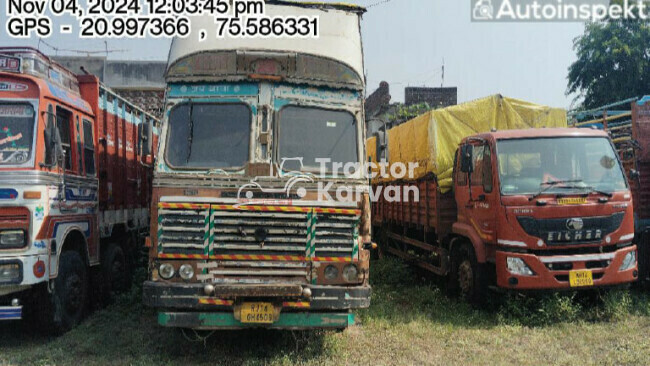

571,96,650,286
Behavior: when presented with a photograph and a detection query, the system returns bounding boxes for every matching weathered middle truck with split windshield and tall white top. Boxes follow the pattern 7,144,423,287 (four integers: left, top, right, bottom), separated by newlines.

143,1,372,329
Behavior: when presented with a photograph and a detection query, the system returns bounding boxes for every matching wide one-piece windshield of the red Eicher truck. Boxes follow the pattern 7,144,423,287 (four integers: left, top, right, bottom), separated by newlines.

497,137,627,195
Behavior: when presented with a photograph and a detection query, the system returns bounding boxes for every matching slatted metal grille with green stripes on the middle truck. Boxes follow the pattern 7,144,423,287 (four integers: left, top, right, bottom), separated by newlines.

158,204,360,257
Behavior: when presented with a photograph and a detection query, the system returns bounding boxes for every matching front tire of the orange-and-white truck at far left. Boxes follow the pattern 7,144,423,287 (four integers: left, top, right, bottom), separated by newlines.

41,251,88,334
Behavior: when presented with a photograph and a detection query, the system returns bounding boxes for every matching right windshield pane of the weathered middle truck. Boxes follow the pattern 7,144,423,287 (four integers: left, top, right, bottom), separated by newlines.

278,106,359,173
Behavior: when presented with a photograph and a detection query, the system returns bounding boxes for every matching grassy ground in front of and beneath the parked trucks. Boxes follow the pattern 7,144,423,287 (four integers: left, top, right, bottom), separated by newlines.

0,260,650,365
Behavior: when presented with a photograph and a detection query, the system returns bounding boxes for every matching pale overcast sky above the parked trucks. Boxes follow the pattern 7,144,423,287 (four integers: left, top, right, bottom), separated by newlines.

0,0,584,108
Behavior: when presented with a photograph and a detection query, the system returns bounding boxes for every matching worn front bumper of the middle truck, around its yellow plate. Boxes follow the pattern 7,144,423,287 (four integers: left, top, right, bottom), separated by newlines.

143,281,372,329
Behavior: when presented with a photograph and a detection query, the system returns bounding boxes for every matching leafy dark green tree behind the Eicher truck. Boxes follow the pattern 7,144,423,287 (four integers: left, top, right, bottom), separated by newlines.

567,20,650,109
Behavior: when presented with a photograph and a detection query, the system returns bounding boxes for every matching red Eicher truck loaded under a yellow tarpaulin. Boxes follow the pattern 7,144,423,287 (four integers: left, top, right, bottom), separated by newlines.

367,95,638,302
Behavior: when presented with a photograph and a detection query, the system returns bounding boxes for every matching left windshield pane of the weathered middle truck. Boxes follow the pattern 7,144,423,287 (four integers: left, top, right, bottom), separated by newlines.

165,103,251,169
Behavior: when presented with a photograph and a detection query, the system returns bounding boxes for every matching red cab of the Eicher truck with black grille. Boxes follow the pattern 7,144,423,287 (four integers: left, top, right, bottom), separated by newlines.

452,128,638,292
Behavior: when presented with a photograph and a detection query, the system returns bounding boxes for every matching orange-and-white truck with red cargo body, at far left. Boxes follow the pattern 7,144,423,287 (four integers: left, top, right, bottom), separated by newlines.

0,48,156,333
